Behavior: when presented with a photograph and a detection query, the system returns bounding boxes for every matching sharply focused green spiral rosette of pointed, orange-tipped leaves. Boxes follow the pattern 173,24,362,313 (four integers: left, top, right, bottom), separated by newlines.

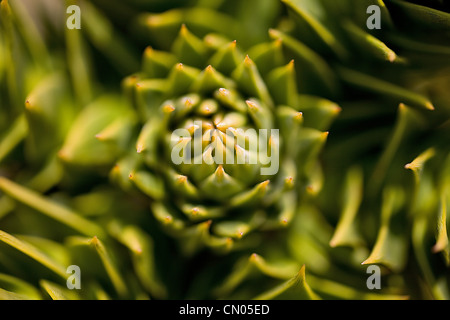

112,13,339,252
